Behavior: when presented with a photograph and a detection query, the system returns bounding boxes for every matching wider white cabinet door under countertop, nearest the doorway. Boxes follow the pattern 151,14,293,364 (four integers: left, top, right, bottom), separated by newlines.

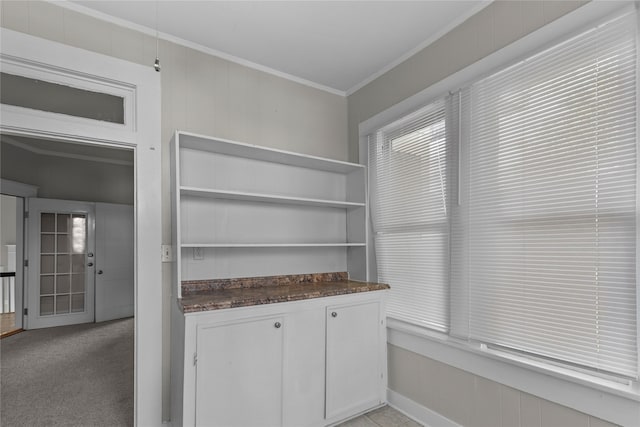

195,317,285,427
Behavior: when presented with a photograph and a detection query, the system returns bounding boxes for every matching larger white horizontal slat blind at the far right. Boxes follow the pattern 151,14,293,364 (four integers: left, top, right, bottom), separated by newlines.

462,10,638,377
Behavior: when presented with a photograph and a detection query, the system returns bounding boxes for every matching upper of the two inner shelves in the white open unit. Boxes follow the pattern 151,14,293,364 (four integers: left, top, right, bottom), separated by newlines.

180,187,365,209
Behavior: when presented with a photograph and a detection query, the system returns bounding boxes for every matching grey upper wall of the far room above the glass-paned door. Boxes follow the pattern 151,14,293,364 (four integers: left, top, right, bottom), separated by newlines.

0,143,134,205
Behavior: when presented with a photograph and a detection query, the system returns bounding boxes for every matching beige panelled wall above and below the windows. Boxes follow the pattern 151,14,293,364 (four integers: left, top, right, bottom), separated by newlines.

348,1,624,427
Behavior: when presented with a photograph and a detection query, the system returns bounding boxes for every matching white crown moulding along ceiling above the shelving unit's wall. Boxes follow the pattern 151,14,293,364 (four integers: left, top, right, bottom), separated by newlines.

45,0,347,97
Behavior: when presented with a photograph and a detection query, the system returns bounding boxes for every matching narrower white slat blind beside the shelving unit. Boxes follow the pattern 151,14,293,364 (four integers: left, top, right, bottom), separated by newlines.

369,100,450,331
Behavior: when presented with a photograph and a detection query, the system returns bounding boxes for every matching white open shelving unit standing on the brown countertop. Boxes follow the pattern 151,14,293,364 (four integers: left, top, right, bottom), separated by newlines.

171,132,367,296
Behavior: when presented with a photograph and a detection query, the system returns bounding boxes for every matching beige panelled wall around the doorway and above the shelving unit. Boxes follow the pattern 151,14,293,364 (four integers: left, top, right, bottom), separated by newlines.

0,0,348,419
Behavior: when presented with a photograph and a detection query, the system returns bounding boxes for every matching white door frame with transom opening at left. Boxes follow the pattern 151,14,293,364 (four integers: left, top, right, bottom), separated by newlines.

0,28,163,426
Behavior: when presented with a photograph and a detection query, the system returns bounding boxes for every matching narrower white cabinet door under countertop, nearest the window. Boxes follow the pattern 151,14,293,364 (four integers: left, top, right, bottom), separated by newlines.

325,302,382,419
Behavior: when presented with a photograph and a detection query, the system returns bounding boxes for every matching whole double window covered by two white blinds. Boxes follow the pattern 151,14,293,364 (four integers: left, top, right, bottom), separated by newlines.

370,9,638,379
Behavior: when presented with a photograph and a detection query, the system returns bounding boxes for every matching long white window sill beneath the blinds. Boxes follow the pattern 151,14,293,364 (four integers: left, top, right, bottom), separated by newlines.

387,318,640,425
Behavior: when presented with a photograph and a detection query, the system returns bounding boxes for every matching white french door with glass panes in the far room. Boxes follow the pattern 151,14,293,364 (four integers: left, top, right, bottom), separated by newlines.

25,198,95,329
